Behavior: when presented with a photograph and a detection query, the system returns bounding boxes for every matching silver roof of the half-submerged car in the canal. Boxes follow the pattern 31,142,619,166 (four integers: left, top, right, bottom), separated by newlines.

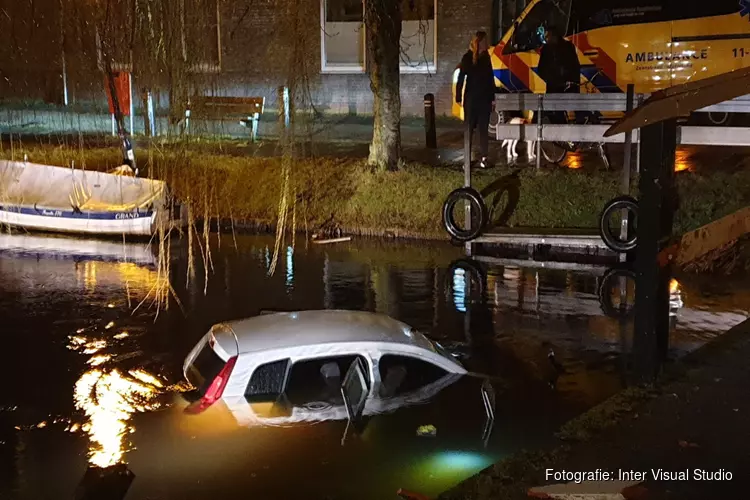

214,310,432,353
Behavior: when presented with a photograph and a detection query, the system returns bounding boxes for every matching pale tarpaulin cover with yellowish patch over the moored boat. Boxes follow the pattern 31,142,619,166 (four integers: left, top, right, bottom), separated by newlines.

0,160,166,212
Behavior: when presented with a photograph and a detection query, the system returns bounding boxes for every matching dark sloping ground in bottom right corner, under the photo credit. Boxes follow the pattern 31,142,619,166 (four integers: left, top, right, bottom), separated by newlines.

441,321,750,500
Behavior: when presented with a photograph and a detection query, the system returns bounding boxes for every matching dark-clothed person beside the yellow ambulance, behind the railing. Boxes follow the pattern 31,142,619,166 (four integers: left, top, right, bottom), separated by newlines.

537,26,581,123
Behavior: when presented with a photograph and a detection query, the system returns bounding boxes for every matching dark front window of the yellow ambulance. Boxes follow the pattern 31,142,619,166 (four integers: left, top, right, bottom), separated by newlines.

503,0,571,54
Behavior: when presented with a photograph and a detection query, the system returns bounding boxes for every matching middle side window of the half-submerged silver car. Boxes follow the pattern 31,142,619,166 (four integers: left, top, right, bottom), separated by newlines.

285,355,370,406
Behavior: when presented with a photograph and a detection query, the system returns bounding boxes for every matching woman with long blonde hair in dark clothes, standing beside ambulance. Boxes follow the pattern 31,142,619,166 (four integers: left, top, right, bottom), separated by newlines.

456,31,495,168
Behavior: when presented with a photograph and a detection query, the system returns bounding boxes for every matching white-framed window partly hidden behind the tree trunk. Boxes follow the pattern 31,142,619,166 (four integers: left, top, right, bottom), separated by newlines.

320,0,437,73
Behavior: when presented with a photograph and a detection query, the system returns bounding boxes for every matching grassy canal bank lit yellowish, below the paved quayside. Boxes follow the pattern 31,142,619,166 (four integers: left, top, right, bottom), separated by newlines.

0,146,750,238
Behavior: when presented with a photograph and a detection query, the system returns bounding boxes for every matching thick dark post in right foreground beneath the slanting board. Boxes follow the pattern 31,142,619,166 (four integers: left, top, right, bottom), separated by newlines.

633,118,677,384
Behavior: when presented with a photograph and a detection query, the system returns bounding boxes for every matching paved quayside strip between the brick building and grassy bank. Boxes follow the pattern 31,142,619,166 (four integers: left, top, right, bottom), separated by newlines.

0,108,516,166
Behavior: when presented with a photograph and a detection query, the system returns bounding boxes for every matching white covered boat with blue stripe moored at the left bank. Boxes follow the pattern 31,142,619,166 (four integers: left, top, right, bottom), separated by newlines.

0,160,185,236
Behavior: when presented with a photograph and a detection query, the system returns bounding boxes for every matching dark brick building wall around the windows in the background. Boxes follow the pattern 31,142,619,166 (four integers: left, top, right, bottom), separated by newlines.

0,0,492,115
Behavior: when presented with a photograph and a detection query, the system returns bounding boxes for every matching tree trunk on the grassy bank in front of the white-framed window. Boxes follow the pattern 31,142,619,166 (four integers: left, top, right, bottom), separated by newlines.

364,0,401,170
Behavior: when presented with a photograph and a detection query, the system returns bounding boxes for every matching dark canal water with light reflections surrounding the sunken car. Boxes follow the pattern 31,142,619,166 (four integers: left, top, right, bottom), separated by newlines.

0,235,750,499
